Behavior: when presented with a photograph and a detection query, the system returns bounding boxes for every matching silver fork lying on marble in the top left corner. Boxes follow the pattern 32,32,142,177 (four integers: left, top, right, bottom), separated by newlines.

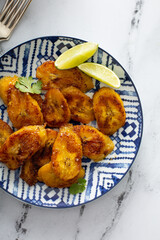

0,0,32,41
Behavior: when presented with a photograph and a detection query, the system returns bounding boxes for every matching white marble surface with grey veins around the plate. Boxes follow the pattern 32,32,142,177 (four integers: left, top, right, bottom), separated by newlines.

0,0,160,240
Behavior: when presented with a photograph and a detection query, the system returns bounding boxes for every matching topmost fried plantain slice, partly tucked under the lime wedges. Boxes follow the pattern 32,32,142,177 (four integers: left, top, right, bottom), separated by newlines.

36,61,93,92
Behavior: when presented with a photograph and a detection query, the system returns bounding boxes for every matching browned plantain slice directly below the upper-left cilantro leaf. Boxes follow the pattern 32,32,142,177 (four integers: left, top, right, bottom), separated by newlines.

7,88,43,129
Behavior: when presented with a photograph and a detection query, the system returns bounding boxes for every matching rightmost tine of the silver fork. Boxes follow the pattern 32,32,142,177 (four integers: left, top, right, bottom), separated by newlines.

7,0,32,30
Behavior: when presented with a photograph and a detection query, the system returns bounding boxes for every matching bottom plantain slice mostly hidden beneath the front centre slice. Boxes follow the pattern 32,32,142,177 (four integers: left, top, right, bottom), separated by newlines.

38,162,85,188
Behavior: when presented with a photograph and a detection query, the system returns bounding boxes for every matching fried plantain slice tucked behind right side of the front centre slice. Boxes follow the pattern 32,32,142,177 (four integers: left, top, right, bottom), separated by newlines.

74,125,114,162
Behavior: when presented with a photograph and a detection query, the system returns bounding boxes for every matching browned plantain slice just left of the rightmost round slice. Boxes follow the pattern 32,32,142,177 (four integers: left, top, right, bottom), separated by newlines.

62,86,95,124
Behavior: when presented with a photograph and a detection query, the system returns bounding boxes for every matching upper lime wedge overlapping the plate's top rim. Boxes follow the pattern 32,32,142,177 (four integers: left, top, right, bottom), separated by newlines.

55,42,98,69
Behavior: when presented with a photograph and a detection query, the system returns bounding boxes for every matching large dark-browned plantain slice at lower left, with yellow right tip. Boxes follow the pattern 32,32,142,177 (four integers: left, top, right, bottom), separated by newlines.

0,126,47,170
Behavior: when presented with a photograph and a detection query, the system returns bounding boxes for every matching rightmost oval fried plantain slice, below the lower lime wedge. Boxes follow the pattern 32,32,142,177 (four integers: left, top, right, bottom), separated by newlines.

93,87,126,135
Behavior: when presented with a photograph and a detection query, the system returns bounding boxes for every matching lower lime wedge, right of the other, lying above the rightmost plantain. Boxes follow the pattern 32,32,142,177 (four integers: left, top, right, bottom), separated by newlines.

78,62,120,88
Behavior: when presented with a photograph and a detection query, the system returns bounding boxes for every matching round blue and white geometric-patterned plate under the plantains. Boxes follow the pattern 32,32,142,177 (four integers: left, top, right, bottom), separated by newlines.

0,37,143,208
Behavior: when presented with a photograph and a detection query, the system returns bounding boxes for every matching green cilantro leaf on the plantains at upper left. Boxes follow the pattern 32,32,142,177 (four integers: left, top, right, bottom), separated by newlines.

15,77,42,94
